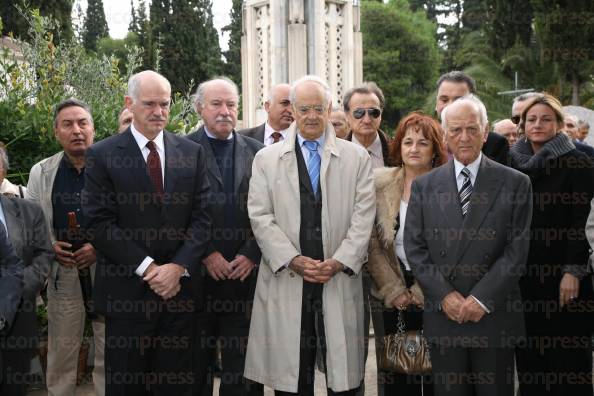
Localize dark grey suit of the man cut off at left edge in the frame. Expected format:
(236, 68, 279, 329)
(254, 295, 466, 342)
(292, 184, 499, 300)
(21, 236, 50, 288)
(0, 180, 54, 396)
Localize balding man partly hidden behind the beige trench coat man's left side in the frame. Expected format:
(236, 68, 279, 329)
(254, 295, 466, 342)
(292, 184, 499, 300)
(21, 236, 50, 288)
(239, 84, 293, 146)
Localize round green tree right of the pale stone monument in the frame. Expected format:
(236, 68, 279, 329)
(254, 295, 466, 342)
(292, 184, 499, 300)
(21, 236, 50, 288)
(361, 0, 440, 132)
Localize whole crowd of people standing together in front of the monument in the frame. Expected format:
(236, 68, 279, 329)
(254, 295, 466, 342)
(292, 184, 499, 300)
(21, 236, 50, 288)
(0, 71, 594, 396)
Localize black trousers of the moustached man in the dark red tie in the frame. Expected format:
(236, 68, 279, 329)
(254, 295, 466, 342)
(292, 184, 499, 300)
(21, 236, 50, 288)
(105, 299, 196, 396)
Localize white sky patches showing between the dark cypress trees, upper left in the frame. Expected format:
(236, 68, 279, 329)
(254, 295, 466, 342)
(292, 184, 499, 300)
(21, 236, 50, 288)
(73, 0, 232, 51)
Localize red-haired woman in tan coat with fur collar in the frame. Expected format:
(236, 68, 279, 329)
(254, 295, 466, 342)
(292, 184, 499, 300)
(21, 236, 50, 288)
(367, 113, 447, 395)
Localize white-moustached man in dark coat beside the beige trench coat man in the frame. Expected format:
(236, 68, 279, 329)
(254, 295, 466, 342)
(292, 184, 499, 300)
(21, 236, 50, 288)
(188, 77, 264, 396)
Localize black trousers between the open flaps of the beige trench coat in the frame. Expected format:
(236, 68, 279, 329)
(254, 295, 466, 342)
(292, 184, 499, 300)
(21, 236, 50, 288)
(274, 281, 359, 396)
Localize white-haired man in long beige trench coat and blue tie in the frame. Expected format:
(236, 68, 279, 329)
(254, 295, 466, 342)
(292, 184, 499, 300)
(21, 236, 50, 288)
(245, 76, 375, 396)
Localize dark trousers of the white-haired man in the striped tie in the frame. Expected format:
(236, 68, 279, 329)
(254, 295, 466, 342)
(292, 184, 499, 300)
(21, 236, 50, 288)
(431, 345, 512, 396)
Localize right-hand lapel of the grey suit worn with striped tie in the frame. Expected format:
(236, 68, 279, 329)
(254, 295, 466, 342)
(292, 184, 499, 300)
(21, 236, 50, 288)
(458, 154, 502, 259)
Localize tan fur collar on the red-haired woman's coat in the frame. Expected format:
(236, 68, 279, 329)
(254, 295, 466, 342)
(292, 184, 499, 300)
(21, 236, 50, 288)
(373, 168, 404, 249)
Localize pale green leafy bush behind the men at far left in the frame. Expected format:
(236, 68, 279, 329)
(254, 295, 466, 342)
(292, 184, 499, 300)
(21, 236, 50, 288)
(0, 7, 197, 184)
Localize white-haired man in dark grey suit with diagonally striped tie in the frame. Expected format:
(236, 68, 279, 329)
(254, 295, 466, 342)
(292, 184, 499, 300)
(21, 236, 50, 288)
(404, 95, 532, 396)
